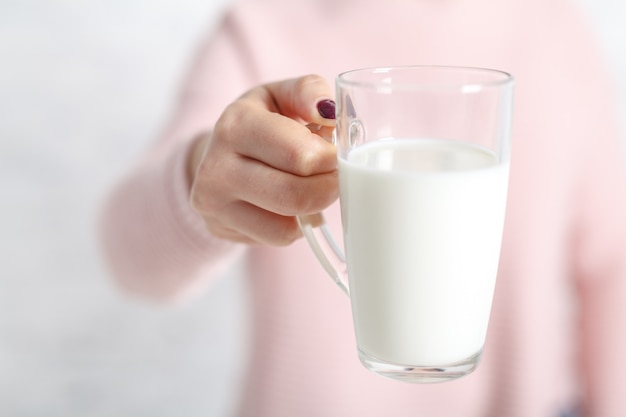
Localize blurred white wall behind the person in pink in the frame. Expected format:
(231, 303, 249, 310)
(0, 0, 626, 417)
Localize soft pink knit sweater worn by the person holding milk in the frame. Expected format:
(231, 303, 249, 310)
(103, 0, 626, 417)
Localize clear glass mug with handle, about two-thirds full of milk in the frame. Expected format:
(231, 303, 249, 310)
(298, 66, 513, 383)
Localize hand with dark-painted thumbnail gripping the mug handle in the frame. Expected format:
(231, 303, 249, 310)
(188, 75, 338, 245)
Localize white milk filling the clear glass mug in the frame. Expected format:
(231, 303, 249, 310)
(339, 139, 508, 366)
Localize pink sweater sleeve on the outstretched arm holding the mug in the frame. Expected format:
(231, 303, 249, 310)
(101, 11, 255, 301)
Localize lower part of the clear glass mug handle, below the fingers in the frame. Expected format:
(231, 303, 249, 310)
(296, 213, 350, 296)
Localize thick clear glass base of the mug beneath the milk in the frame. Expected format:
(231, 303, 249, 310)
(359, 349, 482, 384)
